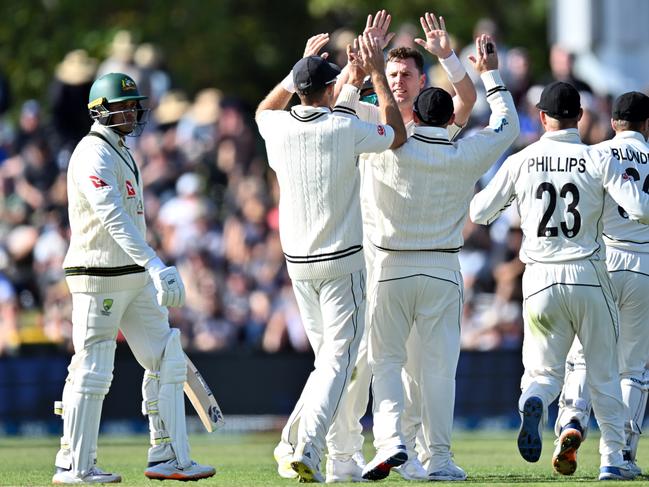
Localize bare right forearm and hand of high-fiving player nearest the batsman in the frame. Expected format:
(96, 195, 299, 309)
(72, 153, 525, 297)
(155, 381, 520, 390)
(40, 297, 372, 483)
(358, 34, 408, 149)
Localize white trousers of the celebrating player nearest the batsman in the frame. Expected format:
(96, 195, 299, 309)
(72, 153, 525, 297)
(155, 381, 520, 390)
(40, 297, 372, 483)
(282, 270, 365, 462)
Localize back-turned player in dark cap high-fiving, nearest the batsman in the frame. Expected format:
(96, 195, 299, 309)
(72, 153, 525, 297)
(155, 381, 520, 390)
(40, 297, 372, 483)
(256, 34, 406, 482)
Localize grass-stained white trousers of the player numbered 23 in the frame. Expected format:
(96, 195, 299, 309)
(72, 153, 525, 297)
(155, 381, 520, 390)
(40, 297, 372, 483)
(519, 261, 624, 466)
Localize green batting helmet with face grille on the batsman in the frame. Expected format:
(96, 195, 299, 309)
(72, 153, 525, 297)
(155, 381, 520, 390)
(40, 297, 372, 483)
(88, 73, 149, 137)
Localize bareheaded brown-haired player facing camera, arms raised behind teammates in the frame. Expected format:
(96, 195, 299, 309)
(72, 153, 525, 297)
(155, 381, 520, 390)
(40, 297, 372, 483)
(327, 10, 476, 482)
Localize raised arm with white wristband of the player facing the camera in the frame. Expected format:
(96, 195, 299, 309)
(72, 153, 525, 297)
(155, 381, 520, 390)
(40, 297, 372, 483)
(415, 12, 477, 126)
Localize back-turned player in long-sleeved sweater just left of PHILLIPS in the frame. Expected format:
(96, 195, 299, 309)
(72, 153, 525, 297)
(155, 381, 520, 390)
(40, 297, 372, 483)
(334, 33, 518, 480)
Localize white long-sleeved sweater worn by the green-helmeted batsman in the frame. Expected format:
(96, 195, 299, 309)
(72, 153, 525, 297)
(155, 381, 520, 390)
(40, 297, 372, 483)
(63, 123, 156, 292)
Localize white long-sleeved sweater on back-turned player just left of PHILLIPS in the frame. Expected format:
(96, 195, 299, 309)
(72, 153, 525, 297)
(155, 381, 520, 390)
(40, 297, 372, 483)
(338, 71, 519, 270)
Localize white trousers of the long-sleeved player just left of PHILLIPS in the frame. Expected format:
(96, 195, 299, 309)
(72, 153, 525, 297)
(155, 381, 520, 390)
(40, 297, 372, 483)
(369, 266, 463, 465)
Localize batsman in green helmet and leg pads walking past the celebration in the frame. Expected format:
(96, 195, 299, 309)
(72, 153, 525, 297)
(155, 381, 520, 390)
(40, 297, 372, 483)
(52, 73, 215, 484)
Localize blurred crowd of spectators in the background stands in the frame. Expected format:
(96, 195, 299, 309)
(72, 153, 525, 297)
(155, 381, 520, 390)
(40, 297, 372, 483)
(0, 19, 636, 355)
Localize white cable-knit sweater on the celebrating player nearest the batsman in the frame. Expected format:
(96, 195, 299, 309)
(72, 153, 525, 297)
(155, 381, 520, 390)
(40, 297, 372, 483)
(257, 105, 394, 279)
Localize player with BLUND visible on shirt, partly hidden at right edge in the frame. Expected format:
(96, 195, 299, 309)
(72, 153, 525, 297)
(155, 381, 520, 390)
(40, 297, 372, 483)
(553, 91, 649, 475)
